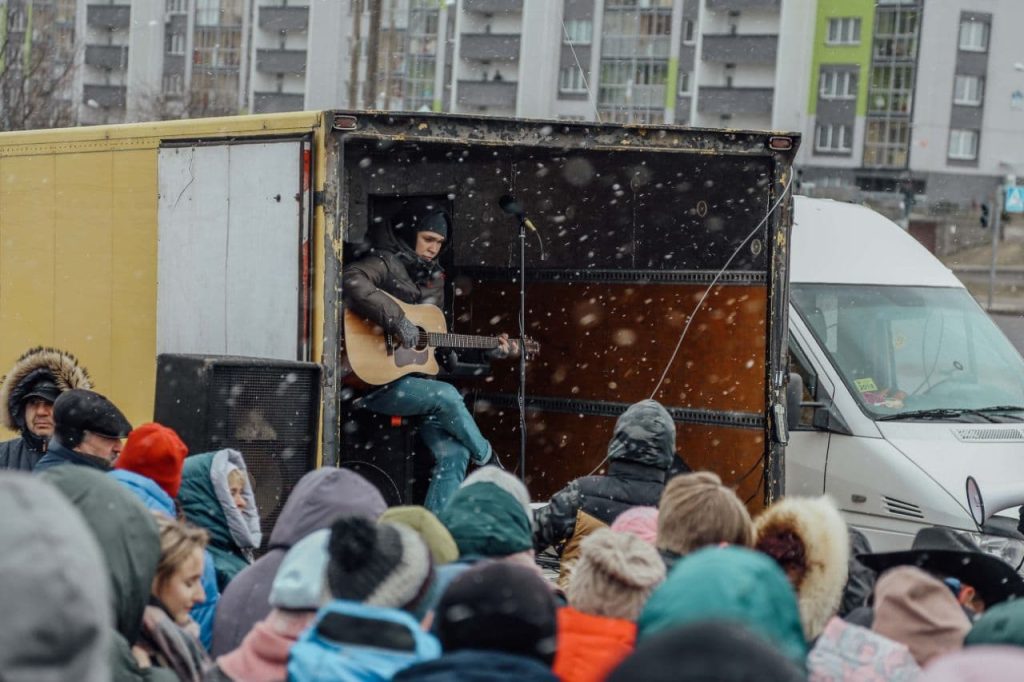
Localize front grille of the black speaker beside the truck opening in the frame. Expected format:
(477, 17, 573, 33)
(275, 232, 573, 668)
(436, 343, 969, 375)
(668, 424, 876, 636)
(208, 365, 318, 543)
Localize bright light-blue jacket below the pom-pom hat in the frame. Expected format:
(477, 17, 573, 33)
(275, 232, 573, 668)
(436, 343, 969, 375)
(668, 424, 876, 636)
(288, 599, 441, 682)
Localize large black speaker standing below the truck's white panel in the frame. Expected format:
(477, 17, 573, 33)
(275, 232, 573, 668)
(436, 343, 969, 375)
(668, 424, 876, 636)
(154, 353, 321, 545)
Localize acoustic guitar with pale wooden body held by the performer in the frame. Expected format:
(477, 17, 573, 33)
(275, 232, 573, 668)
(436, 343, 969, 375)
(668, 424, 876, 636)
(344, 292, 541, 386)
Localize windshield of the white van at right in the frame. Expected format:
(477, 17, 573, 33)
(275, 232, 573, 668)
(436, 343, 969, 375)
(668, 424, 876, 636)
(792, 284, 1024, 421)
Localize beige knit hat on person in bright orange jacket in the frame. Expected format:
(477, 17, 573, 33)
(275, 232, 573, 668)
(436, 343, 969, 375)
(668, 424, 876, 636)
(567, 528, 665, 621)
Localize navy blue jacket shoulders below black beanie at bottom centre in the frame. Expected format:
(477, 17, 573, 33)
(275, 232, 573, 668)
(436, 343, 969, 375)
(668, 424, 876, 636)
(394, 649, 558, 682)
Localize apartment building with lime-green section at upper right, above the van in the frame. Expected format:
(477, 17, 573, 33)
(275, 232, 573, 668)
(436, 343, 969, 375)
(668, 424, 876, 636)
(797, 0, 1024, 219)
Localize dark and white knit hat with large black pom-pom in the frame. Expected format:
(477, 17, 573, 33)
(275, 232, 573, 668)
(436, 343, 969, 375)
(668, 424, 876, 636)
(327, 516, 433, 611)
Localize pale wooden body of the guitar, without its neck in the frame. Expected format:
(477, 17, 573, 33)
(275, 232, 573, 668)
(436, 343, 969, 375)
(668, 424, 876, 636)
(344, 292, 447, 386)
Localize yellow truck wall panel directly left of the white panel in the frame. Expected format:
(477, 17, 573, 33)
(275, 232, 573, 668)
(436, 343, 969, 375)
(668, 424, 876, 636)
(110, 150, 157, 425)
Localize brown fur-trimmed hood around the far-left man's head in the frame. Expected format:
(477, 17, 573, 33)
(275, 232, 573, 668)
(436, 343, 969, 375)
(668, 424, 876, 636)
(0, 346, 92, 431)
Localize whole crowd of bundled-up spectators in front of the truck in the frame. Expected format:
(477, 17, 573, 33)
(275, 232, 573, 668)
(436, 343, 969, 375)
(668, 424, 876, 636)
(0, 349, 1024, 682)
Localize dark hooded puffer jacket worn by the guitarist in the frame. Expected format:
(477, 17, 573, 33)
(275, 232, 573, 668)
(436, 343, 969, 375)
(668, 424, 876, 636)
(342, 206, 451, 334)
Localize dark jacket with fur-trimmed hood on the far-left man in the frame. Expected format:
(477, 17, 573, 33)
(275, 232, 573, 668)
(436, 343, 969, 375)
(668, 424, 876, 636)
(0, 347, 92, 471)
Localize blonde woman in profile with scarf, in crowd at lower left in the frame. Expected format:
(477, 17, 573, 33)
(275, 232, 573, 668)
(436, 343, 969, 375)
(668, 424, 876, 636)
(135, 514, 210, 682)
